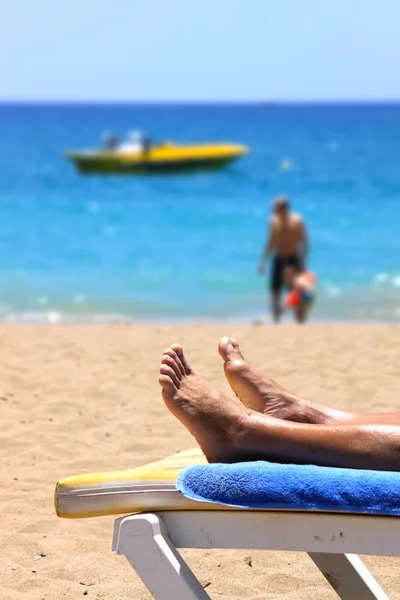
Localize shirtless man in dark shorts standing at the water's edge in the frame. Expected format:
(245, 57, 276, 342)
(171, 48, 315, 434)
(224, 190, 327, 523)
(258, 197, 308, 323)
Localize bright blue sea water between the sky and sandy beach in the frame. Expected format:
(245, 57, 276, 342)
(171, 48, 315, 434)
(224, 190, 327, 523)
(0, 104, 400, 322)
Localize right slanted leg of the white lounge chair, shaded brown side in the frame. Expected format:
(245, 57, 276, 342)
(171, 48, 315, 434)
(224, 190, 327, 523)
(308, 552, 389, 600)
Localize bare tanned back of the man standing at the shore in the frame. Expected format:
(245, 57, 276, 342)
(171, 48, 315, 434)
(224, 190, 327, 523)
(270, 213, 306, 256)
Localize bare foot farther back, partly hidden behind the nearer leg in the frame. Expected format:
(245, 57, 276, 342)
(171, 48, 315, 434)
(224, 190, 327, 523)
(218, 337, 336, 424)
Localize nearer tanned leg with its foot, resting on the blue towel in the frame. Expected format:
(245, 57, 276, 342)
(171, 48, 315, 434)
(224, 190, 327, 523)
(159, 344, 400, 471)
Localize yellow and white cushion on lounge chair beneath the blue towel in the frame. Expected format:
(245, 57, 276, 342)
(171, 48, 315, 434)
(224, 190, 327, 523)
(54, 448, 219, 519)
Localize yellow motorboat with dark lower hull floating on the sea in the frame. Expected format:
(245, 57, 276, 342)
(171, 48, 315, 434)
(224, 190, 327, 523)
(66, 142, 248, 174)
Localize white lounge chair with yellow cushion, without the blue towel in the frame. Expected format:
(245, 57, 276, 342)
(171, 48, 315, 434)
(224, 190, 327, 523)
(56, 449, 400, 600)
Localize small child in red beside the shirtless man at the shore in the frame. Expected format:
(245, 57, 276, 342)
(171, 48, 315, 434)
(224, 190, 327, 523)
(283, 266, 315, 323)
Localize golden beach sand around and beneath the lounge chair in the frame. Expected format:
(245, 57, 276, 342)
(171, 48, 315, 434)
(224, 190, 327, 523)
(0, 325, 400, 600)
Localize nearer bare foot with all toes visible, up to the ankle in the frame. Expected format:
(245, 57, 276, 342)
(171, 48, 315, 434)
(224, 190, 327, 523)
(158, 344, 250, 463)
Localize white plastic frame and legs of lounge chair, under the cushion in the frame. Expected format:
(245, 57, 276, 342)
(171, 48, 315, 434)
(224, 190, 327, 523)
(113, 510, 400, 600)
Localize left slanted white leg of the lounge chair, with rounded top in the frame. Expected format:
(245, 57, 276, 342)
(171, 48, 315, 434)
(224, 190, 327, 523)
(115, 514, 210, 600)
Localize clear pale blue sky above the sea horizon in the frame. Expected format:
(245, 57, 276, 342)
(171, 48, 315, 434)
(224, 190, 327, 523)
(0, 0, 400, 101)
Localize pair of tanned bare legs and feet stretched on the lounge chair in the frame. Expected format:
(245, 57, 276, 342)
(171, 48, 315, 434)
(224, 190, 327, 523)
(158, 337, 400, 471)
